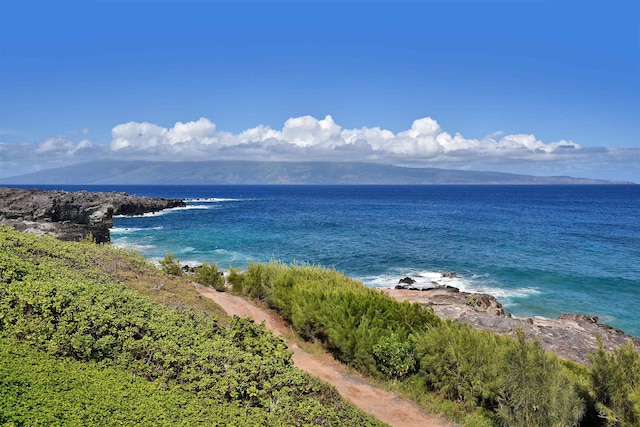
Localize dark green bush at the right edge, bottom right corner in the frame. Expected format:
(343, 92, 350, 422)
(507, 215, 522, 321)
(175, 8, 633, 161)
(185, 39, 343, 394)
(590, 341, 640, 427)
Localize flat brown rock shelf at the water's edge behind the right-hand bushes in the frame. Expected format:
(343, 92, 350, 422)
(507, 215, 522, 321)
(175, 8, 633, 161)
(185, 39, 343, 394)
(381, 273, 640, 364)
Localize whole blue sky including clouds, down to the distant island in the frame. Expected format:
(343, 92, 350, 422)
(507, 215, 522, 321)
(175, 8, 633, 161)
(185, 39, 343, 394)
(0, 0, 640, 182)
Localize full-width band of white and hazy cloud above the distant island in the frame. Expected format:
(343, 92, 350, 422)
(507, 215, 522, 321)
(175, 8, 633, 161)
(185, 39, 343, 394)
(0, 115, 640, 180)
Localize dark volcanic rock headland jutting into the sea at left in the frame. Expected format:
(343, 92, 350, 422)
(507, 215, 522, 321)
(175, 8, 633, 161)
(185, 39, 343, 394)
(0, 187, 185, 243)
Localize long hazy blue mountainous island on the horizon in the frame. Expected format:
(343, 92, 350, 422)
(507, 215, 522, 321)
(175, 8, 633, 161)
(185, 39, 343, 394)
(0, 160, 631, 185)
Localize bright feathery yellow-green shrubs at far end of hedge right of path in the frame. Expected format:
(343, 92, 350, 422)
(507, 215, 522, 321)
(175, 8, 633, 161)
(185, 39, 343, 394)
(229, 261, 440, 375)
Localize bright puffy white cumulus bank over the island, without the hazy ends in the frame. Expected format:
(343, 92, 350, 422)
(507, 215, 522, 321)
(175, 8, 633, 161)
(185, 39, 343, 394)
(110, 115, 582, 165)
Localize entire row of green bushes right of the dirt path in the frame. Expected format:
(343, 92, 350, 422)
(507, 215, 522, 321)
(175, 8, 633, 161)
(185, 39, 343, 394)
(229, 261, 640, 426)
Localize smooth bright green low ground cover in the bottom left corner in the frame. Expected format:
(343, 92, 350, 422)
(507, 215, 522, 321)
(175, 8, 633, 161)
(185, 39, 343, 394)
(0, 338, 272, 426)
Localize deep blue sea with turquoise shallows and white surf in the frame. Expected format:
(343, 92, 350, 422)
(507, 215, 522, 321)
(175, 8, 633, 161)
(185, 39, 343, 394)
(22, 185, 640, 336)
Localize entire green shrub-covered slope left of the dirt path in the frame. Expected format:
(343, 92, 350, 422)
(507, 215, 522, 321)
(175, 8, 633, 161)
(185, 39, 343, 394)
(0, 226, 379, 425)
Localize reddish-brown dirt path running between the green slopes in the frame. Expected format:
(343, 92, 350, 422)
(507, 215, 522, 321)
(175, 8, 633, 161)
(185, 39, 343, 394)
(195, 284, 454, 427)
